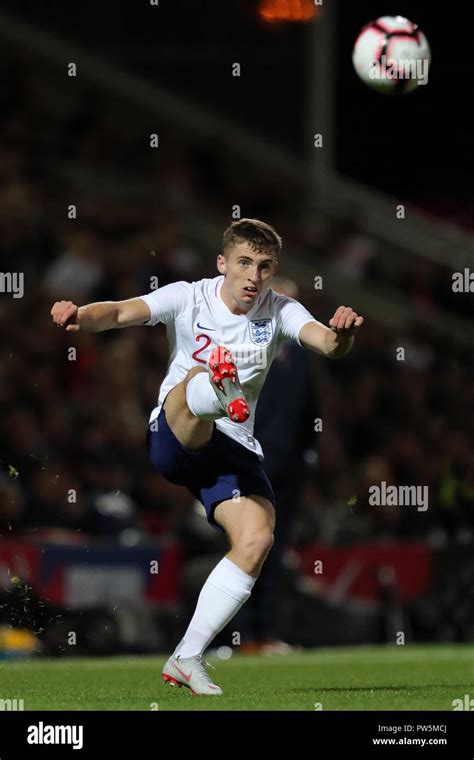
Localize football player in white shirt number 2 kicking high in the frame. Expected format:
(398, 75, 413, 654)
(51, 219, 363, 695)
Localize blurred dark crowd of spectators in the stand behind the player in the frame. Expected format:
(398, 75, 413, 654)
(0, 46, 474, 543)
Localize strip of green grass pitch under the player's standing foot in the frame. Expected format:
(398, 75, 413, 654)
(0, 645, 474, 711)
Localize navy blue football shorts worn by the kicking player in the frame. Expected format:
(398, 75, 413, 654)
(146, 407, 275, 530)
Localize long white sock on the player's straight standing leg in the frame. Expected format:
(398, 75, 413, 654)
(175, 560, 257, 657)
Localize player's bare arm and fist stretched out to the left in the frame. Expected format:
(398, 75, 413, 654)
(51, 298, 151, 332)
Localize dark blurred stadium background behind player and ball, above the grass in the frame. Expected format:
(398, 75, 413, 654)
(0, 0, 474, 656)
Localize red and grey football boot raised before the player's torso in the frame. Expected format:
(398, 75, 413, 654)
(208, 346, 250, 422)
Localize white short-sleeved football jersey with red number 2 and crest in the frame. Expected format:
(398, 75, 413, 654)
(140, 275, 317, 460)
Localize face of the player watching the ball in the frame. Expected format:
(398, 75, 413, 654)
(217, 242, 277, 312)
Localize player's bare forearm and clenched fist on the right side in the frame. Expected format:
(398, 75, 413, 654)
(299, 306, 364, 359)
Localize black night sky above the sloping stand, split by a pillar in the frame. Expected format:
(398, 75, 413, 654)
(2, 0, 474, 202)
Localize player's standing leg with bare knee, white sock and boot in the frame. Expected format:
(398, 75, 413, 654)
(163, 495, 275, 695)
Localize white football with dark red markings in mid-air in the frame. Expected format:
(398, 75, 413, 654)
(352, 16, 431, 94)
